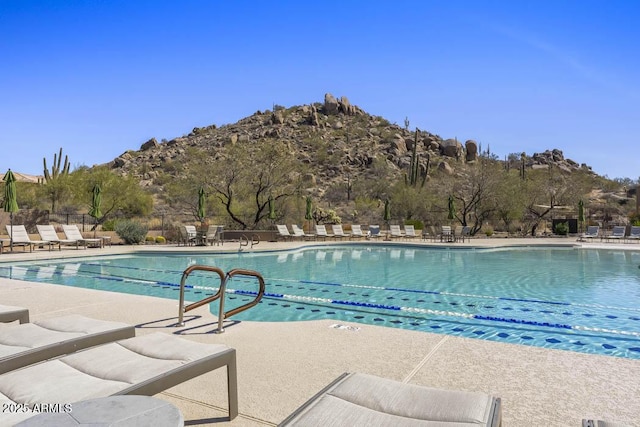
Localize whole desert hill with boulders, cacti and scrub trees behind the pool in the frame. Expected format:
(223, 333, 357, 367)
(3, 94, 638, 239)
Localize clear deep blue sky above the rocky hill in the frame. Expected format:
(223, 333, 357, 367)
(0, 0, 640, 180)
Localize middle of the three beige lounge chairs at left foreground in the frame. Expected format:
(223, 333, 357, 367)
(0, 314, 136, 374)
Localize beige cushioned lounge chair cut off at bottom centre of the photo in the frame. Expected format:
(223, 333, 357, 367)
(279, 373, 502, 427)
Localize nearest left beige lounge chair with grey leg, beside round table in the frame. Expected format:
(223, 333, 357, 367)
(0, 333, 238, 425)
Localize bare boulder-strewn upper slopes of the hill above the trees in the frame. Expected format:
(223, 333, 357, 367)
(110, 93, 590, 196)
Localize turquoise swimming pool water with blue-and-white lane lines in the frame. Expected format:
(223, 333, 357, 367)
(0, 245, 640, 359)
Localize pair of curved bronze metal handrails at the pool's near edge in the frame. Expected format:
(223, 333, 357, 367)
(178, 265, 265, 334)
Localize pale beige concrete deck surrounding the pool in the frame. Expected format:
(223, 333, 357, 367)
(0, 238, 640, 427)
